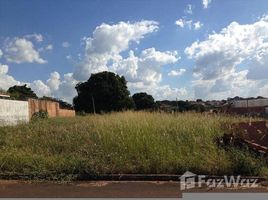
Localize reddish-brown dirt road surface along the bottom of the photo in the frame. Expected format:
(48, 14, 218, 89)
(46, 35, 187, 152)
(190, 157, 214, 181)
(0, 180, 268, 198)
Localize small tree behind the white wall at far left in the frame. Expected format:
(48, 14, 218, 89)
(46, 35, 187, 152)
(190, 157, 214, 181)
(7, 84, 38, 100)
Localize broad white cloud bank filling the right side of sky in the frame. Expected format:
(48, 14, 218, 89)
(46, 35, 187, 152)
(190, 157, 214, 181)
(185, 18, 268, 97)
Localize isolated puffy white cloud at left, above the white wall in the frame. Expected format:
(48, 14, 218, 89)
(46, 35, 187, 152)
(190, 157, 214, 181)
(5, 37, 47, 64)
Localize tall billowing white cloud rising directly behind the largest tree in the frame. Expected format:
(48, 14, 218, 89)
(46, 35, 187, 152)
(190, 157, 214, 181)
(73, 21, 186, 99)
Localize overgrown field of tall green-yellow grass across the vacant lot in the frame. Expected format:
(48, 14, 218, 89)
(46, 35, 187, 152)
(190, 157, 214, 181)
(0, 112, 268, 180)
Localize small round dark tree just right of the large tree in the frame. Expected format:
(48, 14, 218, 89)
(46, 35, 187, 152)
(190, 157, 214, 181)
(132, 92, 155, 110)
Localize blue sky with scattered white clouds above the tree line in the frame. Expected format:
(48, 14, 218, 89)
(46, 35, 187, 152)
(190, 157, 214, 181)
(0, 0, 268, 102)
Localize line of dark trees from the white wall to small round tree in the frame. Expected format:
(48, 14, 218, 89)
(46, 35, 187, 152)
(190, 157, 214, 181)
(1, 71, 156, 113)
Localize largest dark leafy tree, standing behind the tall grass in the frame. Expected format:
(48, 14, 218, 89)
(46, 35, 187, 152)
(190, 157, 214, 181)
(73, 71, 134, 113)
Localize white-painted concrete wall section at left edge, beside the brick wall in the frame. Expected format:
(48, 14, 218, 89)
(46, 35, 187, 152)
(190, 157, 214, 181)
(0, 99, 29, 126)
